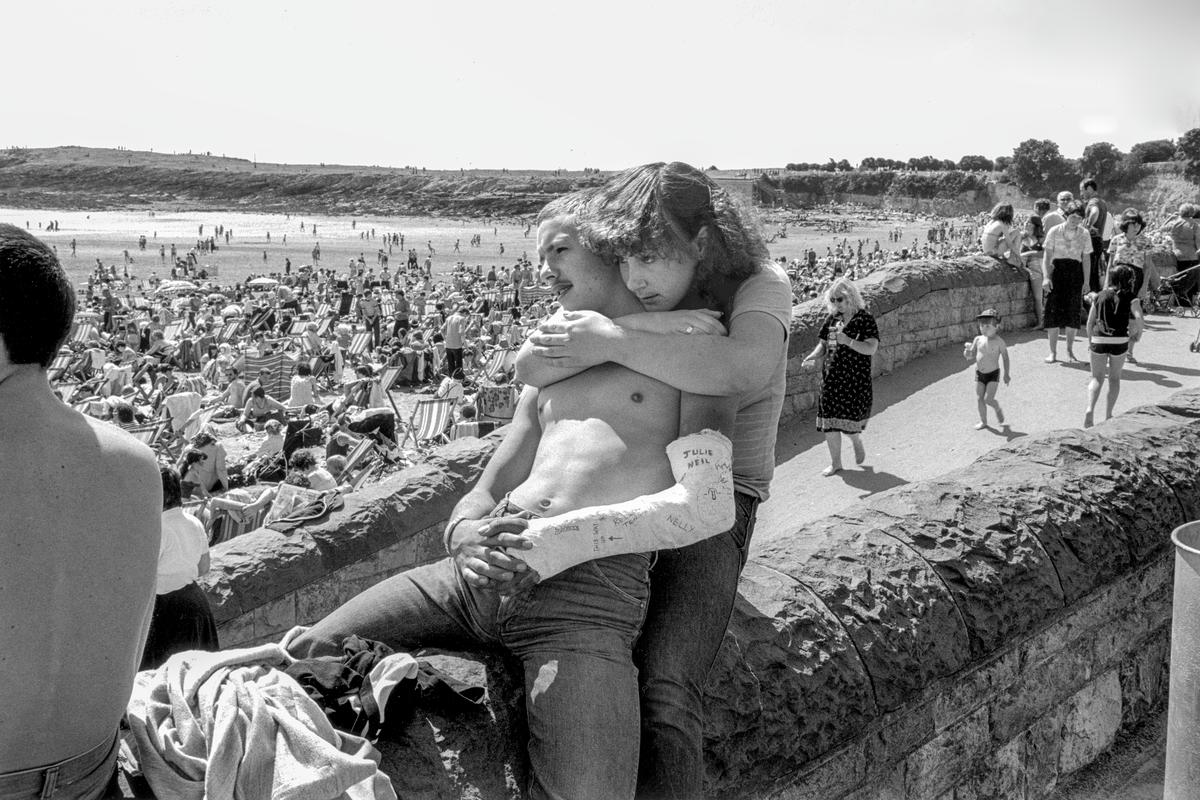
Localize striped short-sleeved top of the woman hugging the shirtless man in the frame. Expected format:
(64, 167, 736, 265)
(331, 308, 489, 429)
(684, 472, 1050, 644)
(730, 261, 792, 500)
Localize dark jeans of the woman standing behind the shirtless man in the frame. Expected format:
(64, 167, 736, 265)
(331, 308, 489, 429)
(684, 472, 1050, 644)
(634, 492, 758, 800)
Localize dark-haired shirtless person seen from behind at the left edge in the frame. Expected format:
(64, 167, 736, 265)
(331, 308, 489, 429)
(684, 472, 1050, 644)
(0, 225, 162, 800)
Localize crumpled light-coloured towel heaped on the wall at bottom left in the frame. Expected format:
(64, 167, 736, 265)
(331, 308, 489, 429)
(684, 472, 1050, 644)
(125, 644, 396, 800)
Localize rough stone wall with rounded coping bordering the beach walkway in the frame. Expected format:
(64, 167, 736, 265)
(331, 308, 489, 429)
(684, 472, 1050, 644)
(206, 258, 1185, 800)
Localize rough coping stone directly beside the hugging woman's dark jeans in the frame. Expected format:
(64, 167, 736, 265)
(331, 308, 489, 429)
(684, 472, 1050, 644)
(704, 561, 876, 794)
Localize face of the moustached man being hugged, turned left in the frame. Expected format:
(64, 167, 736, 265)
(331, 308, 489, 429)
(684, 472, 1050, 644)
(538, 217, 625, 311)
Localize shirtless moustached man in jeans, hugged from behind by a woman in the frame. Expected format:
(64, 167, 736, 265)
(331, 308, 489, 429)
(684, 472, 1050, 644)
(289, 199, 733, 800)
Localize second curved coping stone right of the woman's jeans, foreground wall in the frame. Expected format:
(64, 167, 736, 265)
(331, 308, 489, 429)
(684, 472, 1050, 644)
(754, 515, 968, 709)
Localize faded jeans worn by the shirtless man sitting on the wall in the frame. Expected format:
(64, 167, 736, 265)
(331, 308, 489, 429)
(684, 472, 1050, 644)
(289, 504, 650, 800)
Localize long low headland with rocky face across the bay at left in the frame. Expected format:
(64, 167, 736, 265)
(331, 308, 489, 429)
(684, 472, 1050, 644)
(0, 148, 601, 217)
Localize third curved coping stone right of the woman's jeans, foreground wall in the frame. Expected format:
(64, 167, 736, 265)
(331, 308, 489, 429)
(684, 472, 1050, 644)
(849, 480, 1064, 657)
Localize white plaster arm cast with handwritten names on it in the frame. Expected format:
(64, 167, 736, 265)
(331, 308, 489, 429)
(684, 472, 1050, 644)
(512, 429, 734, 581)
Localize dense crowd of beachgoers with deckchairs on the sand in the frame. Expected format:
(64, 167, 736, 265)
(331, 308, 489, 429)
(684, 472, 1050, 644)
(49, 191, 1190, 539)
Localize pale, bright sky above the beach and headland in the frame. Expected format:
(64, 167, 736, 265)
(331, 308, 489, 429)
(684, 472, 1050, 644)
(0, 0, 1200, 169)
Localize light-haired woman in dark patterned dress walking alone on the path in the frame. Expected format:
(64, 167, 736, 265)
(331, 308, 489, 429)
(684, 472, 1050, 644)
(804, 278, 880, 476)
